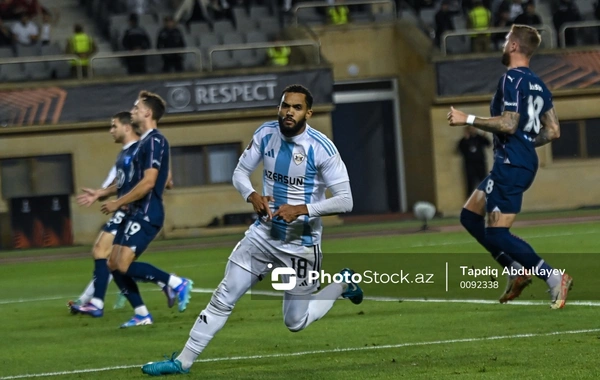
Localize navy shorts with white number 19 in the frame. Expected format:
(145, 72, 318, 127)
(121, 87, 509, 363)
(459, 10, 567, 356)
(113, 215, 161, 257)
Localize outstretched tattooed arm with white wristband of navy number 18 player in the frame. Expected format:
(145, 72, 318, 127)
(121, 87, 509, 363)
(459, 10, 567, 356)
(448, 107, 520, 135)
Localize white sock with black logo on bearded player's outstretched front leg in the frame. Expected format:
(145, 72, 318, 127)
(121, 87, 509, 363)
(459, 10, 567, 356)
(177, 305, 229, 369)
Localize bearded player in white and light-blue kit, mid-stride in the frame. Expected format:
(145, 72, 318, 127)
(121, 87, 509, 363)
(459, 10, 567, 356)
(142, 85, 363, 376)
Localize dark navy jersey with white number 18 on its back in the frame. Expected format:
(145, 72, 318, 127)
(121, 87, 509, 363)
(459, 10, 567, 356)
(490, 67, 553, 172)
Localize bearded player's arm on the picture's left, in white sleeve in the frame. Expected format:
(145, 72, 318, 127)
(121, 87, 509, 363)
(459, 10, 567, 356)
(231, 135, 273, 220)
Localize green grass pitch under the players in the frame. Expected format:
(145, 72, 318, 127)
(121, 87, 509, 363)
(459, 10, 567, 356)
(0, 218, 600, 380)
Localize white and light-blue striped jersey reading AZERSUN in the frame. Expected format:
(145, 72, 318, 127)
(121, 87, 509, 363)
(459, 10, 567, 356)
(240, 121, 350, 247)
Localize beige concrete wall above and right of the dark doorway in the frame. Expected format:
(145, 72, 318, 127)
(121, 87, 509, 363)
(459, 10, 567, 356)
(315, 20, 435, 209)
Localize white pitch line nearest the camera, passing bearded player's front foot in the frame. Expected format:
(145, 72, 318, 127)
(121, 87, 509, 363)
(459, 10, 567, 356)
(0, 329, 600, 380)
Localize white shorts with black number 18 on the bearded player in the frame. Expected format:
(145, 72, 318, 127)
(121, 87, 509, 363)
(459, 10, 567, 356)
(229, 229, 323, 295)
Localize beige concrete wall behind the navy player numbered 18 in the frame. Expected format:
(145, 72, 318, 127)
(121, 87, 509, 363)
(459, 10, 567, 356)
(431, 95, 600, 215)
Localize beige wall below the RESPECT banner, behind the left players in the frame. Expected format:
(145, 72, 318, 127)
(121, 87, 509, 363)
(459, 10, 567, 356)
(0, 110, 331, 243)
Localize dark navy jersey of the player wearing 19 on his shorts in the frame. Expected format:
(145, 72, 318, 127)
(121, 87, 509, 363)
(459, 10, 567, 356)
(130, 129, 170, 226)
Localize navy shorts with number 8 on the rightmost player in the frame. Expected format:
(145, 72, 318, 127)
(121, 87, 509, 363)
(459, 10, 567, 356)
(477, 163, 535, 214)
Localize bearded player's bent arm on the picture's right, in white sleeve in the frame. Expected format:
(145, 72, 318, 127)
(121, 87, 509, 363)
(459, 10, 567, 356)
(273, 154, 353, 223)
